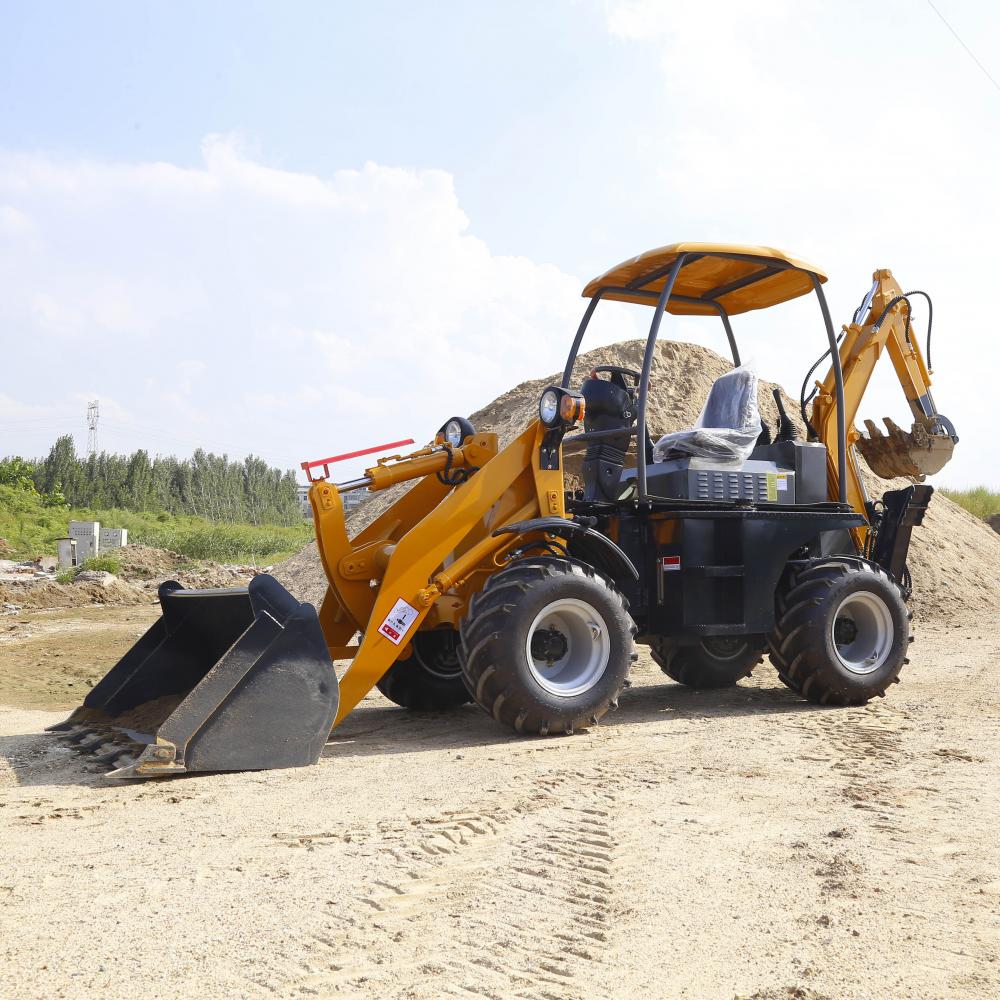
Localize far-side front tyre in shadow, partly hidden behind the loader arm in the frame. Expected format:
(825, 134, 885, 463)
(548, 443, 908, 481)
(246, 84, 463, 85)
(375, 628, 472, 712)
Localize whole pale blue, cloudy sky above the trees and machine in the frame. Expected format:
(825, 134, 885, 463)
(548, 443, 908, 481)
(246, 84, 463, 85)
(0, 0, 1000, 486)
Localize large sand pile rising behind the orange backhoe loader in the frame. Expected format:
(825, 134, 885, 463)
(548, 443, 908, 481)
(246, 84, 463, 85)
(274, 340, 1000, 619)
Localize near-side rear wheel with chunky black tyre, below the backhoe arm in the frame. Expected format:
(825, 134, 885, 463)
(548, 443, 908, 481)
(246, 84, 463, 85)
(770, 560, 910, 705)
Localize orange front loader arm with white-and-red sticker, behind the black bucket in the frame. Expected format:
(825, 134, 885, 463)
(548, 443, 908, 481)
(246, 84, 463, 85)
(309, 421, 565, 725)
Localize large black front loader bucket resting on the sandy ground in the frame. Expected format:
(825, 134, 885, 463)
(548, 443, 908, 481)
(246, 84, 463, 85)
(52, 575, 339, 777)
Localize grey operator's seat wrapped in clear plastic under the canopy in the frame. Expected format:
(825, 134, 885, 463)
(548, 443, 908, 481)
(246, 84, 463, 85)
(653, 366, 762, 466)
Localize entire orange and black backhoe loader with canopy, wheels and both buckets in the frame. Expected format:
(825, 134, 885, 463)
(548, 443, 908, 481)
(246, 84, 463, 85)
(50, 243, 958, 777)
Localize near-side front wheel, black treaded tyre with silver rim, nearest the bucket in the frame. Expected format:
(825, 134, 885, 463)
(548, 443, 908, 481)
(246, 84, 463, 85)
(460, 557, 636, 736)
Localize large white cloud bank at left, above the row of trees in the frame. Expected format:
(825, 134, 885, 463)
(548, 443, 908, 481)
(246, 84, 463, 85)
(0, 136, 583, 476)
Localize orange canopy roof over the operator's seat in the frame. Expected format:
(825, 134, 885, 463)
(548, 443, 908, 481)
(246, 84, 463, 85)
(583, 243, 826, 316)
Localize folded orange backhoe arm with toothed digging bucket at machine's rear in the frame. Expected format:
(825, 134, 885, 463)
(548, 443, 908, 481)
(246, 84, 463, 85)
(810, 269, 958, 550)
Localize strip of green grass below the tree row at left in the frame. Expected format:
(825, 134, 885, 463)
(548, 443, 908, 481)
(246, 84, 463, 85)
(0, 485, 313, 572)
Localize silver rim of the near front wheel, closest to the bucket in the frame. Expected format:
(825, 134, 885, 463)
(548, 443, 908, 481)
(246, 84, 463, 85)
(524, 598, 611, 698)
